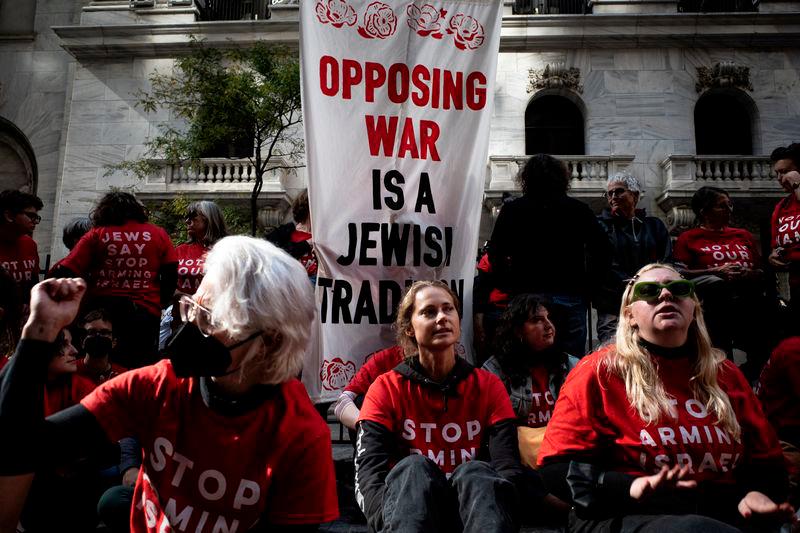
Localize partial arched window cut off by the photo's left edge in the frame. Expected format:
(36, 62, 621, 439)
(0, 117, 37, 194)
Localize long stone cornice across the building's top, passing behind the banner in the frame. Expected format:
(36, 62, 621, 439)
(53, 13, 800, 59)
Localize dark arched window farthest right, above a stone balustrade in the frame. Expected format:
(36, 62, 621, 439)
(694, 89, 755, 155)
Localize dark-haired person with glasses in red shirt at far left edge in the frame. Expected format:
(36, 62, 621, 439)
(0, 189, 44, 298)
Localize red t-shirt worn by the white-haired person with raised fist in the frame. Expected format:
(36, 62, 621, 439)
(81, 360, 339, 533)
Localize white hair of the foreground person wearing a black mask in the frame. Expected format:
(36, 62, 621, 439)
(204, 235, 314, 384)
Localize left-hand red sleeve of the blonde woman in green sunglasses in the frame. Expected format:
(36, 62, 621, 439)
(538, 354, 616, 466)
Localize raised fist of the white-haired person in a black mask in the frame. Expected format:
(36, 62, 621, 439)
(22, 278, 86, 342)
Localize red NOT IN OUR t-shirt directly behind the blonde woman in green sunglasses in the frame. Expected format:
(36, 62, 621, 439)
(675, 227, 760, 270)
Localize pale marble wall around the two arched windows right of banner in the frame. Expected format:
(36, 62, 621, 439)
(489, 48, 800, 216)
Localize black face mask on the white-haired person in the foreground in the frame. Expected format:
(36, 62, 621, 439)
(164, 322, 261, 377)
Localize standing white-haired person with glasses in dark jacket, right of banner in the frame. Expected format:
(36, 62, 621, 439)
(593, 171, 672, 342)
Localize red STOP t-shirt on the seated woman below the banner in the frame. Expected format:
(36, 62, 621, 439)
(359, 368, 515, 476)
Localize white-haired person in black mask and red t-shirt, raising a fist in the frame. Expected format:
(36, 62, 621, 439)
(0, 237, 338, 533)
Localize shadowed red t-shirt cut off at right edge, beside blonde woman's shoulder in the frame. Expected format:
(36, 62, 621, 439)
(757, 337, 800, 445)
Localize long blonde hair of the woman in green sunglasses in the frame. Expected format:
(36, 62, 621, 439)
(604, 263, 741, 441)
